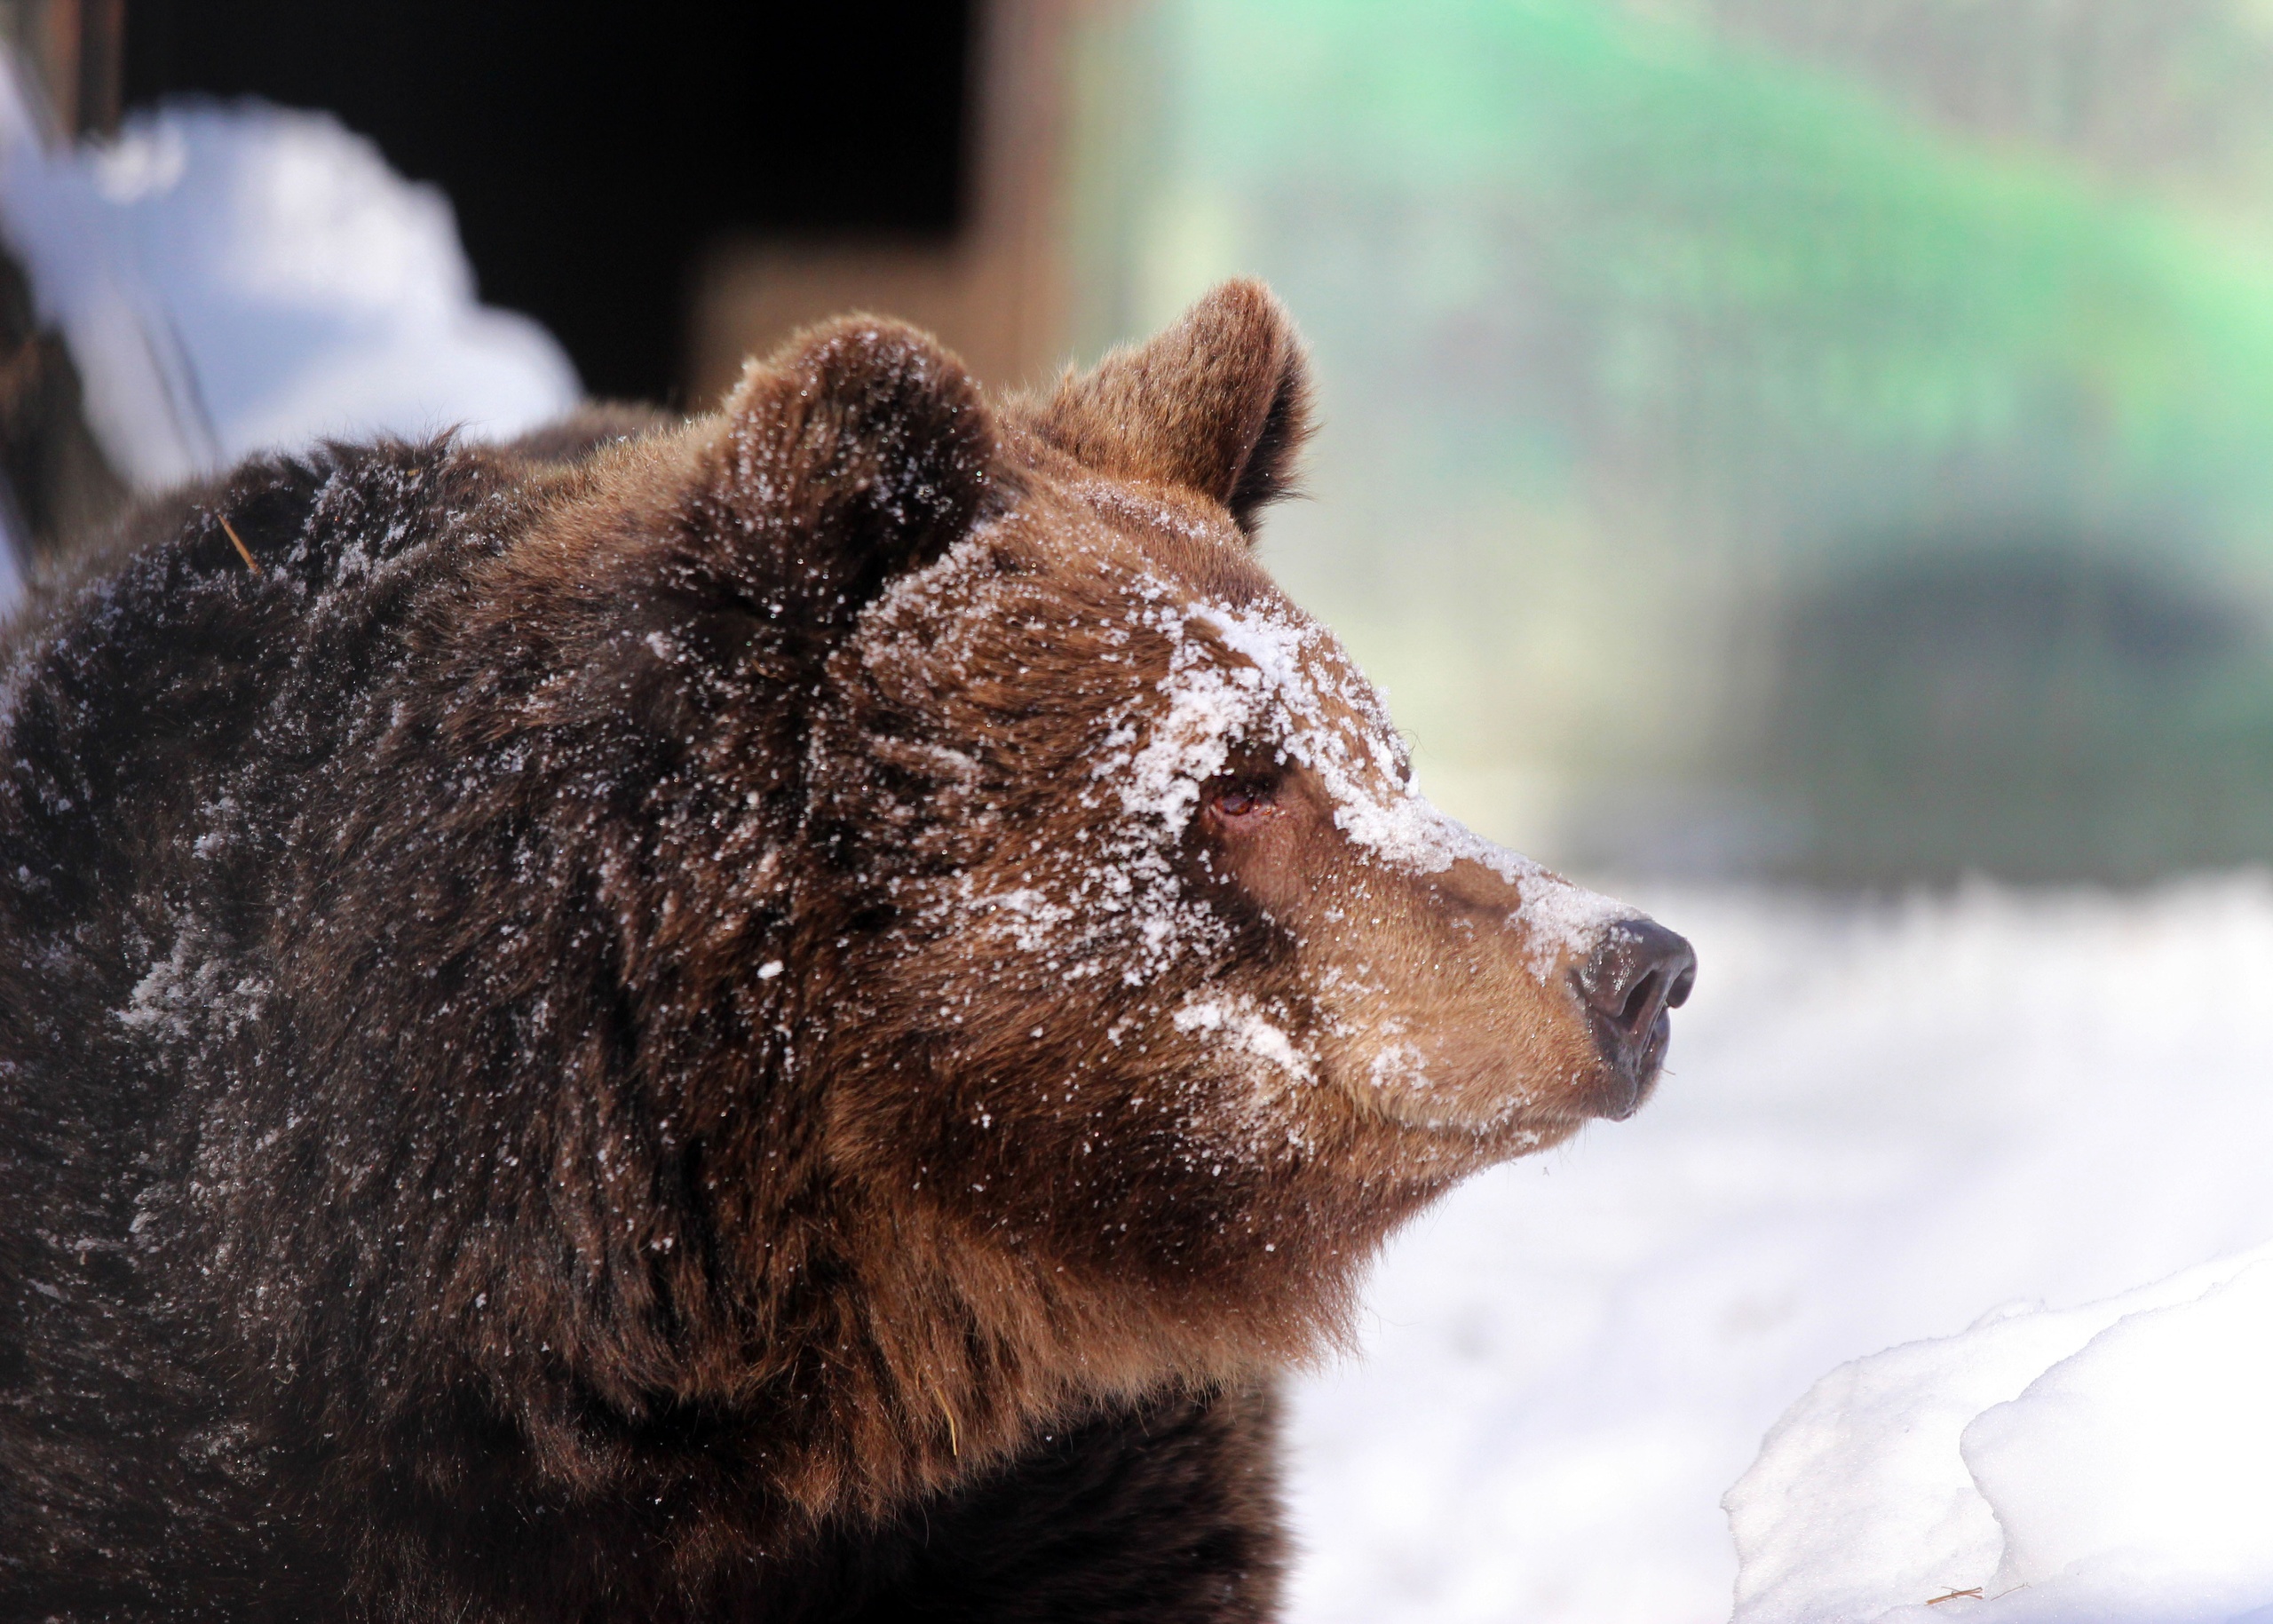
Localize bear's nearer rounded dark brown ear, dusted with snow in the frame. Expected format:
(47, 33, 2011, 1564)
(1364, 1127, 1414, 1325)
(721, 316, 995, 621)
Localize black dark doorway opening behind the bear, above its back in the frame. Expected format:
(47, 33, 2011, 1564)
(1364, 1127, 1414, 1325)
(125, 0, 975, 400)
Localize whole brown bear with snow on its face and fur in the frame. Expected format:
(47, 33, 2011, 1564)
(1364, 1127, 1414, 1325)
(0, 284, 1691, 1624)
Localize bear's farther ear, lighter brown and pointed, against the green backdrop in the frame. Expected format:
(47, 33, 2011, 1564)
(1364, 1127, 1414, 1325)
(1036, 282, 1310, 535)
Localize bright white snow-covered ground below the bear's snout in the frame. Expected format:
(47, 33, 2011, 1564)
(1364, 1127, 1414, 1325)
(1291, 875, 2273, 1624)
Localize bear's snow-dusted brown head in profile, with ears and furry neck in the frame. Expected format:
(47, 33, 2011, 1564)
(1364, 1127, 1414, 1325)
(418, 282, 1691, 1501)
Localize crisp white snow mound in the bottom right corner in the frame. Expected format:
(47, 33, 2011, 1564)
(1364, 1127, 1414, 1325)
(1725, 1247, 2273, 1624)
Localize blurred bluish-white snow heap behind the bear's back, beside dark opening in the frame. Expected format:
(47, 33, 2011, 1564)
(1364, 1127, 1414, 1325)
(0, 53, 580, 489)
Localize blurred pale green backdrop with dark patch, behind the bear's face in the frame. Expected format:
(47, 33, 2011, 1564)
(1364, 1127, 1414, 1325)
(1071, 0, 2273, 883)
